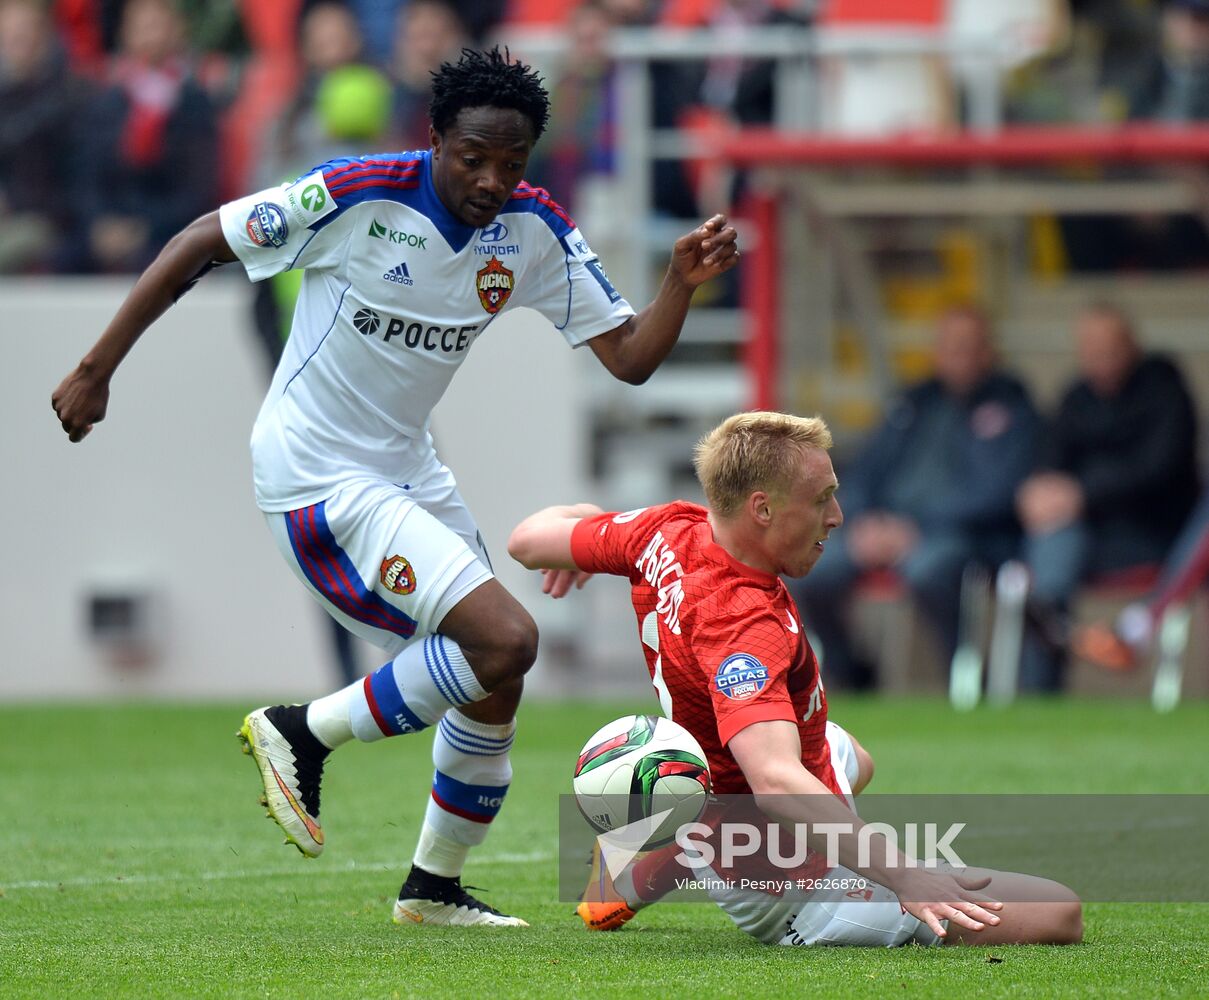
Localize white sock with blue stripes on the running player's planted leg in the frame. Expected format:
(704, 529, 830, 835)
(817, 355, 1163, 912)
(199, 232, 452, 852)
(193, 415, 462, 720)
(413, 709, 516, 877)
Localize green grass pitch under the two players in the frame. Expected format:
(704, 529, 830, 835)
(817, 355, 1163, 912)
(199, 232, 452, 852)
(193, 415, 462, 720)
(0, 696, 1209, 1000)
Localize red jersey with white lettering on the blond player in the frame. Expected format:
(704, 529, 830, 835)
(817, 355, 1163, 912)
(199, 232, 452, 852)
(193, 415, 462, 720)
(571, 502, 841, 794)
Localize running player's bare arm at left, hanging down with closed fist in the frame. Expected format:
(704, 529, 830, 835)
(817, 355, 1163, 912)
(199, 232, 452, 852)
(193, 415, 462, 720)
(51, 212, 236, 441)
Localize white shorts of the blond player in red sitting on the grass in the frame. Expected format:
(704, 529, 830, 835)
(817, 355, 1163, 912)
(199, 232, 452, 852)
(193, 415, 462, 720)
(696, 722, 941, 948)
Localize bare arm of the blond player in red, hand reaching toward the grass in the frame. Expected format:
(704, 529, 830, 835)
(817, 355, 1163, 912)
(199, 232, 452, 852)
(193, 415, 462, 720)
(728, 721, 1003, 938)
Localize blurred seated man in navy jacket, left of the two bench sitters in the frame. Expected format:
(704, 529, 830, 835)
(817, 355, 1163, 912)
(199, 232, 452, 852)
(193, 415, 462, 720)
(791, 307, 1037, 687)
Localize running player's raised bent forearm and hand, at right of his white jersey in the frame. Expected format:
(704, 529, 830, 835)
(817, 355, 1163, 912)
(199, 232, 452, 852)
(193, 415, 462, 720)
(588, 215, 739, 386)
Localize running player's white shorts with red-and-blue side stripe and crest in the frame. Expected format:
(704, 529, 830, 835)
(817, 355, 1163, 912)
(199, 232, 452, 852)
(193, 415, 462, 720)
(265, 462, 492, 657)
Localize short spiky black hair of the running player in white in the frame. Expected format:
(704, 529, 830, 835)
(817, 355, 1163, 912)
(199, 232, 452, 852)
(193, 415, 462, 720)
(428, 45, 550, 139)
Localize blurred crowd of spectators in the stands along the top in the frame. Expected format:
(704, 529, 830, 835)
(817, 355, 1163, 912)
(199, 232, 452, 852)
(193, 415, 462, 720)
(7, 0, 1209, 273)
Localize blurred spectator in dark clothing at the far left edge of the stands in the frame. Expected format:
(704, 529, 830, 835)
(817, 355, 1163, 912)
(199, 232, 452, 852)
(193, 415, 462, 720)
(0, 0, 83, 272)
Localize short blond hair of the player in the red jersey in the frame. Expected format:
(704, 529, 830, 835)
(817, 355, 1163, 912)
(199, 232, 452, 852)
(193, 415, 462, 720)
(693, 410, 832, 518)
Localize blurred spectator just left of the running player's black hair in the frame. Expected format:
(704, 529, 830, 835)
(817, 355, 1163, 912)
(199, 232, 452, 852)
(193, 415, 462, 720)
(391, 0, 470, 149)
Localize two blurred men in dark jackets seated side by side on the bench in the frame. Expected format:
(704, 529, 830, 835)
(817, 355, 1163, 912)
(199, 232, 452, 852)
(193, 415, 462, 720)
(791, 301, 1209, 692)
